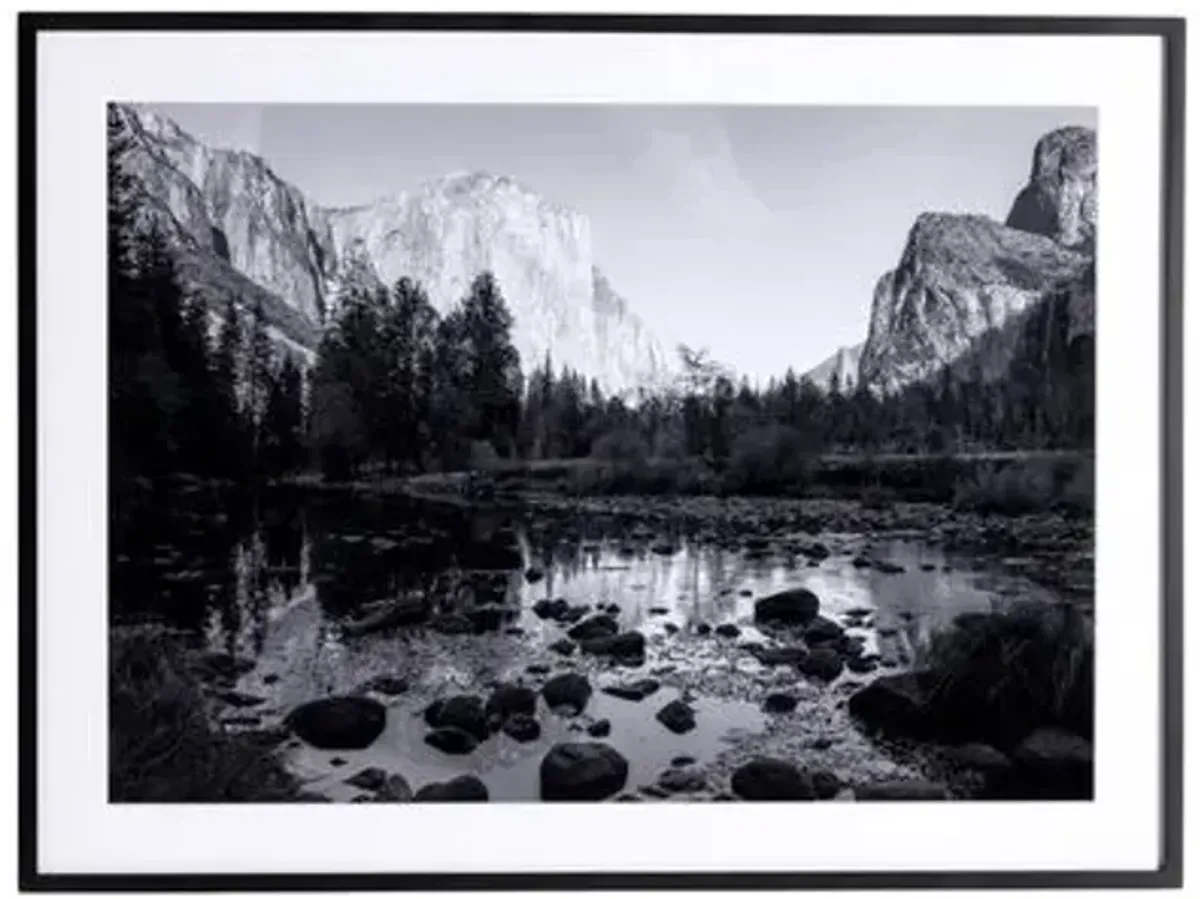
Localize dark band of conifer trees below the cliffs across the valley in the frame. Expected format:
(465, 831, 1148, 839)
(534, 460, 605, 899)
(108, 100, 1093, 492)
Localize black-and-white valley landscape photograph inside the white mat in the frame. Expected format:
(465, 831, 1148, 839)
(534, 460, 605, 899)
(107, 103, 1103, 803)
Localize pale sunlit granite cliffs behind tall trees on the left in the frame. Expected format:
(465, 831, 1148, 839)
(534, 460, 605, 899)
(110, 106, 671, 391)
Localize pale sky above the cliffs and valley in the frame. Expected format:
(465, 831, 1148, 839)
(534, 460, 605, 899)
(145, 104, 1096, 380)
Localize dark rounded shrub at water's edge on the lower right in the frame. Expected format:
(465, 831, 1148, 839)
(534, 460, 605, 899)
(923, 601, 1094, 749)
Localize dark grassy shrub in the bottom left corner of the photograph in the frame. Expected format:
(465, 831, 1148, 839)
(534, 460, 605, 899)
(108, 628, 302, 802)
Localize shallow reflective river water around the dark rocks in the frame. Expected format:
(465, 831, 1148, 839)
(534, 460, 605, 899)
(112, 492, 1065, 801)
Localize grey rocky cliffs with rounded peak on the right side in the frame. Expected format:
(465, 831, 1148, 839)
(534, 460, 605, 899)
(859, 127, 1097, 390)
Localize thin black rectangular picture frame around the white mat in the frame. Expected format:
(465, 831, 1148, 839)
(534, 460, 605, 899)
(18, 13, 1186, 892)
